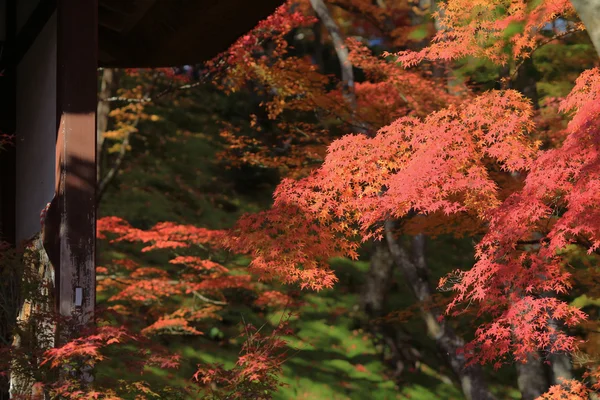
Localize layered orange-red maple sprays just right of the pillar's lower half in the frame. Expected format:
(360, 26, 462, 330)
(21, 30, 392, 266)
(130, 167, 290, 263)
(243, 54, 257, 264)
(96, 217, 300, 335)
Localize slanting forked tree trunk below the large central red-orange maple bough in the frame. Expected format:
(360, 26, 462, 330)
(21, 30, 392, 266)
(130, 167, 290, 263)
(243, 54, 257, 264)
(385, 221, 495, 400)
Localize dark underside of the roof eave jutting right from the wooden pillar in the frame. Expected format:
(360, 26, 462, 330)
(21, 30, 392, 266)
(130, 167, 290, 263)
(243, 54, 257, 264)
(98, 0, 283, 67)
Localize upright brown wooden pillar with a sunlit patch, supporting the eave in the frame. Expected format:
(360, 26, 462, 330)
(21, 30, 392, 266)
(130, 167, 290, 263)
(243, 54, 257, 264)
(49, 0, 98, 332)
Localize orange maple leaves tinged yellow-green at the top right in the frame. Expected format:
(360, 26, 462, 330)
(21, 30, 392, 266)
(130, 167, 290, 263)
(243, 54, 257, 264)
(398, 0, 583, 67)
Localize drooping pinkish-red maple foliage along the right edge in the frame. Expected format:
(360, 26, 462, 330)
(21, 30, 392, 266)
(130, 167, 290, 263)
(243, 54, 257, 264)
(452, 69, 600, 366)
